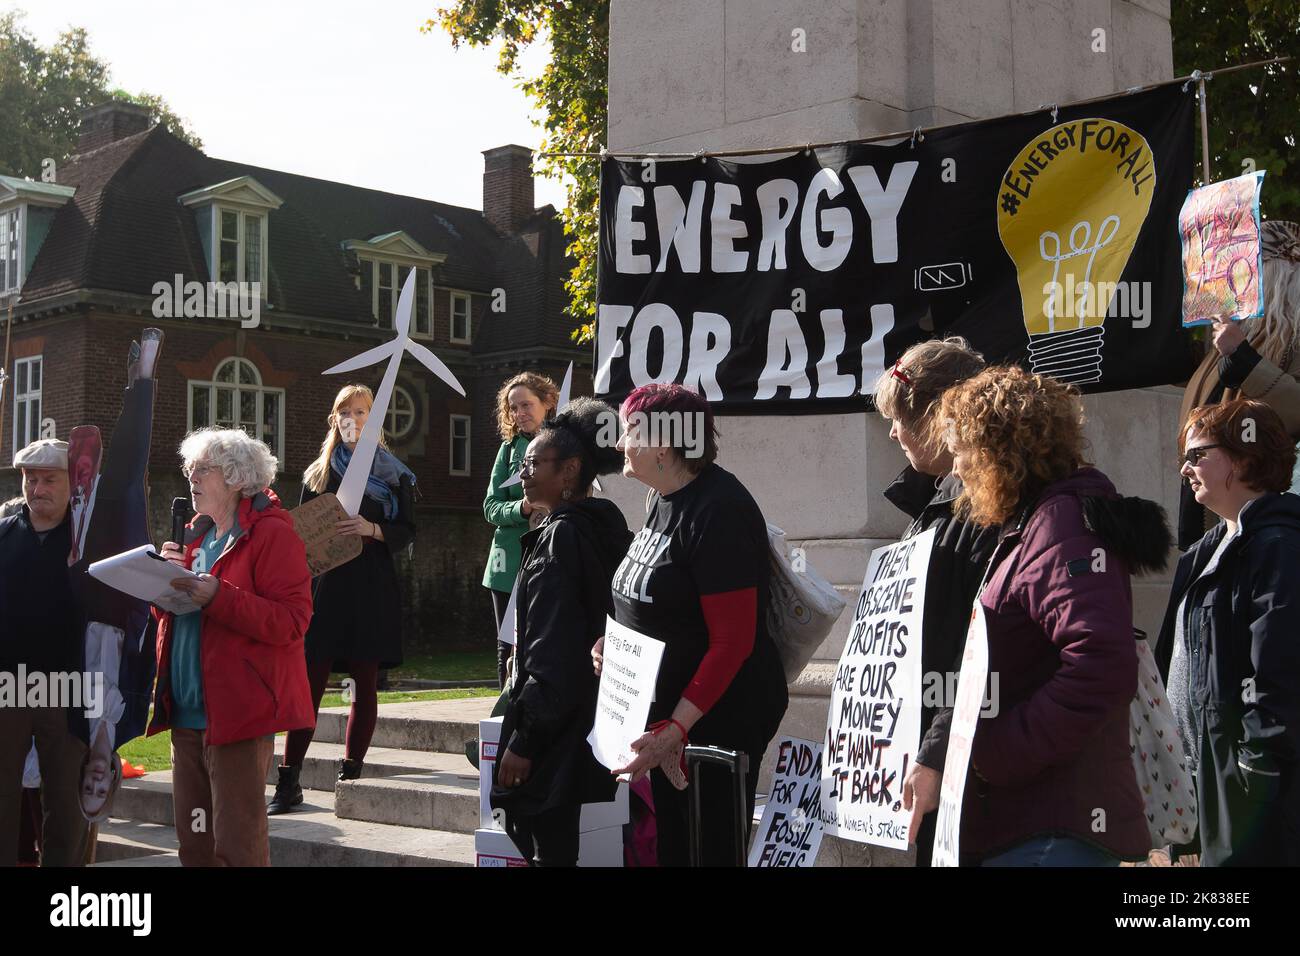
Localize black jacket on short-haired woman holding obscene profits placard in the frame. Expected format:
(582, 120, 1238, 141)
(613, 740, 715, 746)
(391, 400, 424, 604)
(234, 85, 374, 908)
(885, 466, 1000, 773)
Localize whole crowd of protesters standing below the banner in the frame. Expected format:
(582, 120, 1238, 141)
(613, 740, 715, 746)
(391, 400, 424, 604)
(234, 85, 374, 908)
(0, 222, 1300, 866)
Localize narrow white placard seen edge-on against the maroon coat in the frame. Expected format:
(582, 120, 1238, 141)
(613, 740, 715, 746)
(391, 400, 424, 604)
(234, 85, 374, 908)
(930, 600, 988, 866)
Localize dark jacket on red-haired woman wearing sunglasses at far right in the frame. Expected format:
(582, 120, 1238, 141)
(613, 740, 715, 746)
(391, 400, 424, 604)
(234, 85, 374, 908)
(1156, 494, 1300, 866)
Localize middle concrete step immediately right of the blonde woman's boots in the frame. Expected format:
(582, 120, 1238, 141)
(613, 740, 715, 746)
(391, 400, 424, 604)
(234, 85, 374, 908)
(334, 775, 478, 834)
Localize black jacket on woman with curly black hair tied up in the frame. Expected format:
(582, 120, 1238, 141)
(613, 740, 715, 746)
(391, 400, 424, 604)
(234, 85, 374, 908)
(491, 498, 632, 816)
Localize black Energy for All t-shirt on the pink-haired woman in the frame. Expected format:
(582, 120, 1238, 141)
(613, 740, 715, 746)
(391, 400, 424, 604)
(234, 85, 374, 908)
(612, 464, 787, 743)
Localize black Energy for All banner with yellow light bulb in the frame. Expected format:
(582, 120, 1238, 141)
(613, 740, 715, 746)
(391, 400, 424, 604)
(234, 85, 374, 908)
(595, 85, 1195, 414)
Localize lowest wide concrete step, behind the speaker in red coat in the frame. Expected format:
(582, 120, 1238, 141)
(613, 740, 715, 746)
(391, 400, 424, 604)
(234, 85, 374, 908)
(101, 773, 477, 866)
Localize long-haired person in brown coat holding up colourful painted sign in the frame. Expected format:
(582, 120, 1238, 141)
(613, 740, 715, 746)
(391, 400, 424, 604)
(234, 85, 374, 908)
(1178, 220, 1300, 550)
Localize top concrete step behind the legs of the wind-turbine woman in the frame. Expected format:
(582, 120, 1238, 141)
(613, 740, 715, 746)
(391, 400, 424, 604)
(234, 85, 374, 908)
(315, 697, 497, 754)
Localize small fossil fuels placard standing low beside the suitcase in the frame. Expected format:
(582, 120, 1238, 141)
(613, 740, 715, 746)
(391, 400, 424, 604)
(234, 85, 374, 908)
(749, 737, 826, 868)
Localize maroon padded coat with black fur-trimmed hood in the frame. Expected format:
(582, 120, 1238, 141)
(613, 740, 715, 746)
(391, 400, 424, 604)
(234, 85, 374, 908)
(961, 468, 1170, 861)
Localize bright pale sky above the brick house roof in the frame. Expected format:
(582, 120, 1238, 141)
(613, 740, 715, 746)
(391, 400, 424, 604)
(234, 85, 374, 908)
(8, 0, 564, 209)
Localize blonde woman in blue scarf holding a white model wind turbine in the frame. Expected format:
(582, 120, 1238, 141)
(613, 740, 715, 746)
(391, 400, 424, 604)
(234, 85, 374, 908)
(267, 385, 416, 816)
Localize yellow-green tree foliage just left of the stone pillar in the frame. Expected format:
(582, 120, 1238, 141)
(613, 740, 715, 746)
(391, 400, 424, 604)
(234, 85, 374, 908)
(421, 0, 610, 342)
